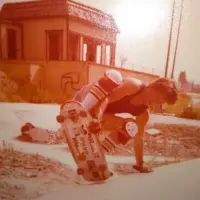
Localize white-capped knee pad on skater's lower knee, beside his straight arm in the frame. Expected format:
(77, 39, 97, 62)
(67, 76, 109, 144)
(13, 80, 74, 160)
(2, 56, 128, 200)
(118, 119, 138, 145)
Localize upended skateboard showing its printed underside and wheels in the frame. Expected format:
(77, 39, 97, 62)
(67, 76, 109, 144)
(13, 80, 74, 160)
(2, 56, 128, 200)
(56, 101, 113, 182)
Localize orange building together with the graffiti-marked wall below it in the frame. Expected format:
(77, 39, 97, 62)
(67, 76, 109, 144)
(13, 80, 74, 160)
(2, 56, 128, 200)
(0, 0, 158, 100)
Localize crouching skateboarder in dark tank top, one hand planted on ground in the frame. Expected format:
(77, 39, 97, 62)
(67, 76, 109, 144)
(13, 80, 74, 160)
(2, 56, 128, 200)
(22, 70, 178, 173)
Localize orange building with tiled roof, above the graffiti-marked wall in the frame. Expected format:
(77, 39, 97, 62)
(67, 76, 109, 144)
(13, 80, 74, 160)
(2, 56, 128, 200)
(0, 0, 119, 65)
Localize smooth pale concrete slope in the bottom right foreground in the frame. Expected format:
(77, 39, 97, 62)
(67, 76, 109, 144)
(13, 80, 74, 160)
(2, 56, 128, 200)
(38, 159, 200, 200)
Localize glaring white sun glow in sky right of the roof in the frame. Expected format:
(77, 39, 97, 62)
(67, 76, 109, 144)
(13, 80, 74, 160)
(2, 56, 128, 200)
(115, 0, 166, 37)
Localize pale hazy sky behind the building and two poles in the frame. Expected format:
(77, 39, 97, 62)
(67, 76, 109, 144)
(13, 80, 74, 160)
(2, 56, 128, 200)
(0, 0, 200, 83)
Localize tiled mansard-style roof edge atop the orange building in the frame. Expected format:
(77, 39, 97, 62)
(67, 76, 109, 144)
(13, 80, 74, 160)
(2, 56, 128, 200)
(0, 0, 119, 33)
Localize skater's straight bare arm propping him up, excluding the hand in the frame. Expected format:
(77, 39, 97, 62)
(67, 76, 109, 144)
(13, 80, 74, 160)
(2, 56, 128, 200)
(133, 111, 149, 166)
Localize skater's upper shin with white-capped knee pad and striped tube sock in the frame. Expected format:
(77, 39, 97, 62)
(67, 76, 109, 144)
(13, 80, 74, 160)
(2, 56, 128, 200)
(82, 70, 122, 111)
